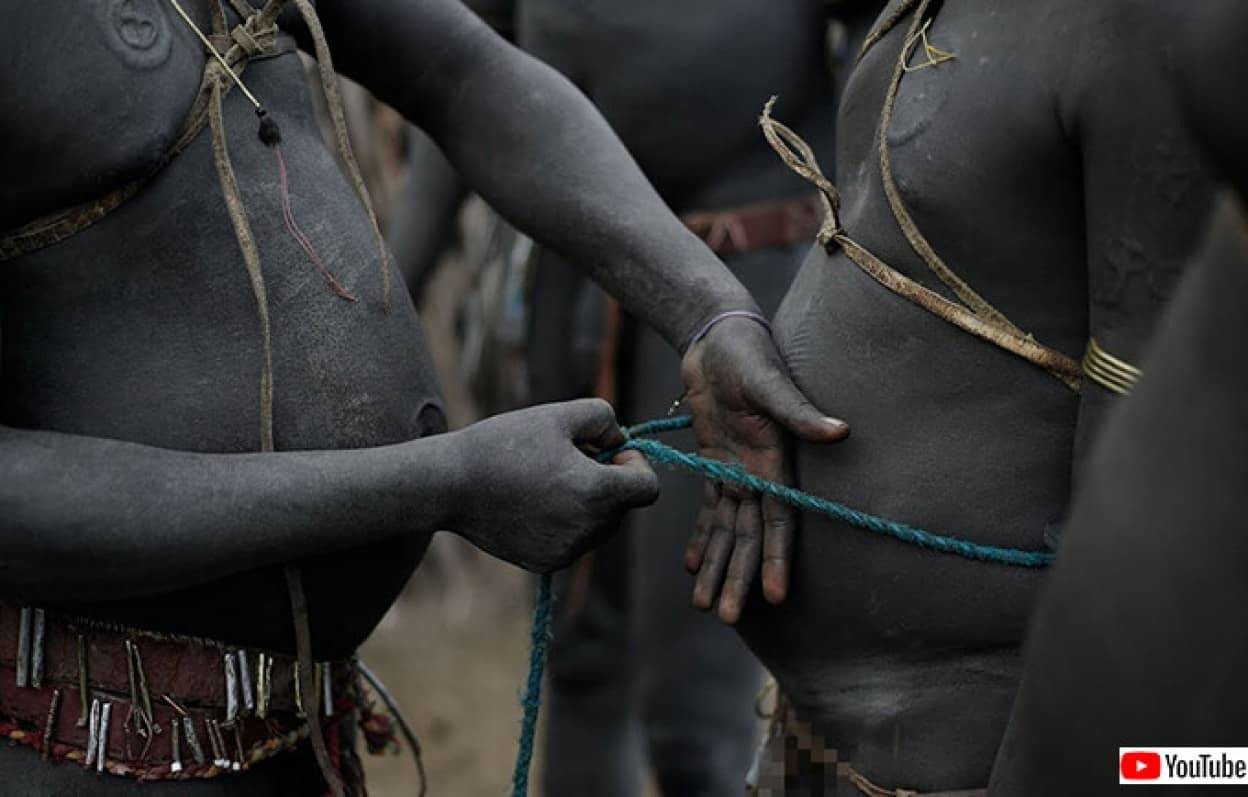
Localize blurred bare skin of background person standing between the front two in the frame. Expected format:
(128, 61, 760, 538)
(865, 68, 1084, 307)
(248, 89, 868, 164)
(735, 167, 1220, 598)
(511, 0, 874, 797)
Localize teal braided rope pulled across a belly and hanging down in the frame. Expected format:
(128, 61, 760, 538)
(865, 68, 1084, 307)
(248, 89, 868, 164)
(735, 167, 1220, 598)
(512, 415, 1053, 797)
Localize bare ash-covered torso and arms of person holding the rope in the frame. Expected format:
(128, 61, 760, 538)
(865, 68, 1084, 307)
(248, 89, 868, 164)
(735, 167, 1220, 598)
(0, 0, 844, 795)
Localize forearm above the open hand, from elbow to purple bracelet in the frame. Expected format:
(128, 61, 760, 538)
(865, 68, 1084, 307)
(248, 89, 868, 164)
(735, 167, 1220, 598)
(433, 57, 756, 352)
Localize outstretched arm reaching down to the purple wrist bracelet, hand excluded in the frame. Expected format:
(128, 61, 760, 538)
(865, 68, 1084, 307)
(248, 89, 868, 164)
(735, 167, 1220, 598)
(312, 0, 756, 349)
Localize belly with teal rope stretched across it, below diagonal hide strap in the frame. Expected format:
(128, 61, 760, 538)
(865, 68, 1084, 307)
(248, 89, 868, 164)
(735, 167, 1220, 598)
(744, 248, 1077, 671)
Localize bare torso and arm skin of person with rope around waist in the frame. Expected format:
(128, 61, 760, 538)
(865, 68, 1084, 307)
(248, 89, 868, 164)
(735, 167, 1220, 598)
(723, 0, 1211, 793)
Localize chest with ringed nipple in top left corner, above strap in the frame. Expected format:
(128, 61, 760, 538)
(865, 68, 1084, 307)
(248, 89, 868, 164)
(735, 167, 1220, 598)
(0, 0, 214, 229)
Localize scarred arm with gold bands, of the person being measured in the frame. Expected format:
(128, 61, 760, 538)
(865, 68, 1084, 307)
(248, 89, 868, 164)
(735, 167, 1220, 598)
(1061, 0, 1213, 478)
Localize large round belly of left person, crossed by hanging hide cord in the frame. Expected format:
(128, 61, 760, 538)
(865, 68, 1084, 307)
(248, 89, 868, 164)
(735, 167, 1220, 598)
(0, 59, 442, 657)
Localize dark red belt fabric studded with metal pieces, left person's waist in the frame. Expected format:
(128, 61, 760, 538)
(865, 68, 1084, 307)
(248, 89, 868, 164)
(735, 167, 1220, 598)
(0, 604, 354, 780)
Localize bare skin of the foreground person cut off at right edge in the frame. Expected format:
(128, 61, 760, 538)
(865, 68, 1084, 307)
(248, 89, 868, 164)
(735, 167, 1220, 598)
(992, 0, 1248, 796)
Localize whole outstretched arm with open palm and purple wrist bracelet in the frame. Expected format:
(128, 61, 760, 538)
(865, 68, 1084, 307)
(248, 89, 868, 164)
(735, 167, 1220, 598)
(300, 0, 847, 621)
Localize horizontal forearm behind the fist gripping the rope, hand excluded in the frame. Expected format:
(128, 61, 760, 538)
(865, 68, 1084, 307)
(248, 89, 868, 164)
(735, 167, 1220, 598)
(0, 427, 457, 601)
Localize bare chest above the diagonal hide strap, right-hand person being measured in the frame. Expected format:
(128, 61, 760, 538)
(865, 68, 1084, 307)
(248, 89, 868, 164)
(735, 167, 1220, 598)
(818, 0, 1087, 349)
